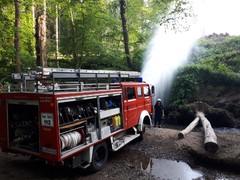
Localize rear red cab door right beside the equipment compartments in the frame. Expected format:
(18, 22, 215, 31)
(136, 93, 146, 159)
(124, 87, 138, 128)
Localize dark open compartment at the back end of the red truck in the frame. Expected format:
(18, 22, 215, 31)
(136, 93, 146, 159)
(8, 102, 39, 153)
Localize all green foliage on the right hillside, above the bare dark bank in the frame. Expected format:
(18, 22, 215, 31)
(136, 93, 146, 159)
(170, 34, 240, 106)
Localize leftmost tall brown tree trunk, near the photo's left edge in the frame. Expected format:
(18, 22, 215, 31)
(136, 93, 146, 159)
(14, 0, 21, 73)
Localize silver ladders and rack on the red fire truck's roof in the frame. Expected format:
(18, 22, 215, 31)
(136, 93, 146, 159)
(8, 67, 140, 92)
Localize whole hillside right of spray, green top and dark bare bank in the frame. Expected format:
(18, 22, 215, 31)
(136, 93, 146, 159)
(169, 34, 240, 127)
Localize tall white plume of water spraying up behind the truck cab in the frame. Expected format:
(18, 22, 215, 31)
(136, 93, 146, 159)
(142, 27, 198, 102)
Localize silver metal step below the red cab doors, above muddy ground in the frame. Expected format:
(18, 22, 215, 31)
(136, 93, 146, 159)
(112, 134, 140, 151)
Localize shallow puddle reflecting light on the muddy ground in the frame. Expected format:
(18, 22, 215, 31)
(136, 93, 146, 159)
(141, 158, 204, 180)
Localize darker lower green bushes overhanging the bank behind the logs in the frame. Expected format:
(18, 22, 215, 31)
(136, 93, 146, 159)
(170, 60, 240, 105)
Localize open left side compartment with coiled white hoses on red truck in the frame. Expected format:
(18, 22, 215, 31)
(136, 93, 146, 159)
(58, 98, 98, 153)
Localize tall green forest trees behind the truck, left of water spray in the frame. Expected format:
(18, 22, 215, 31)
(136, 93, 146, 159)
(0, 0, 187, 79)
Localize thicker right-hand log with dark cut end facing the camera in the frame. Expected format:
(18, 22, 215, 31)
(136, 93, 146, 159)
(197, 112, 219, 153)
